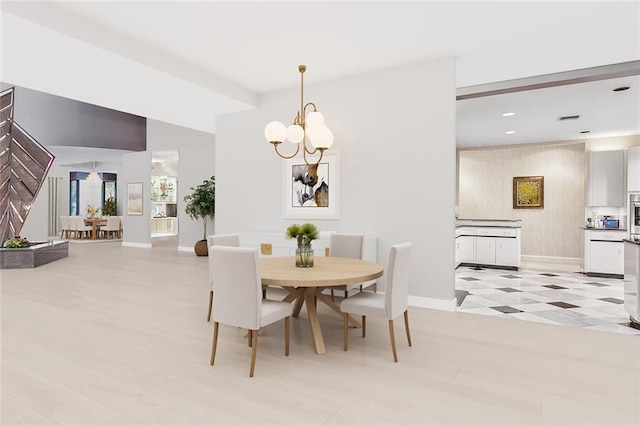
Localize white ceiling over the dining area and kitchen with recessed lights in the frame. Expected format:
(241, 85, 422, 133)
(1, 1, 640, 158)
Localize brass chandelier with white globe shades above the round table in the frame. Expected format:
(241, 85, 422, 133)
(264, 65, 333, 165)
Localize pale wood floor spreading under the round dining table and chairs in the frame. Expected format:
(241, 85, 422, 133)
(0, 240, 640, 425)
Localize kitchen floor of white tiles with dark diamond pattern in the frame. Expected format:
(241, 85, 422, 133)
(456, 266, 640, 336)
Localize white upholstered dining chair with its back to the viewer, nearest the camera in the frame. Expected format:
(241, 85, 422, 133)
(209, 245, 291, 377)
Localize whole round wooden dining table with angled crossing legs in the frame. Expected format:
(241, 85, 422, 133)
(260, 256, 384, 355)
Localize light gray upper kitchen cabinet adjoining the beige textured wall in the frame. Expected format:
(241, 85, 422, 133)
(587, 150, 625, 207)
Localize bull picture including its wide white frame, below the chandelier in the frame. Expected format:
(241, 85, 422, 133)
(283, 154, 340, 219)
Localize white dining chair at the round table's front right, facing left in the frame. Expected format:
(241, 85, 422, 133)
(340, 242, 411, 362)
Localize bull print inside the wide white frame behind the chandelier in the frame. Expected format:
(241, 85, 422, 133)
(291, 163, 330, 207)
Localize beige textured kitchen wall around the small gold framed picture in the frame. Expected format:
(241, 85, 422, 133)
(458, 143, 585, 258)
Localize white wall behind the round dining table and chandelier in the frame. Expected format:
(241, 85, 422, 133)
(216, 58, 456, 309)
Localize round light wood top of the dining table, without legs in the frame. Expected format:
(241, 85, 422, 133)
(260, 256, 384, 287)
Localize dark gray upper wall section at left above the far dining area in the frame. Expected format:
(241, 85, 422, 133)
(0, 82, 147, 151)
